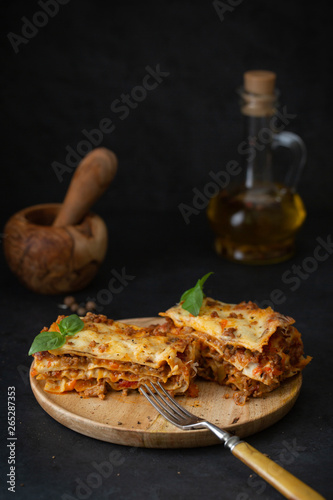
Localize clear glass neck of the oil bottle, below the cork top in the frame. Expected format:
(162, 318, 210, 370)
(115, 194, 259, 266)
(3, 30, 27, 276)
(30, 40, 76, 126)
(237, 91, 276, 189)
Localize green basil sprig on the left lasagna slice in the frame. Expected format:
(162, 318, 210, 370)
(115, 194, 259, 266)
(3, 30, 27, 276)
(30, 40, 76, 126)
(29, 314, 84, 356)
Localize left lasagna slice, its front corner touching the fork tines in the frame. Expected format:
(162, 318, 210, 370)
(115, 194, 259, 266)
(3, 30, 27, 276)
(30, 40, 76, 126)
(32, 313, 198, 399)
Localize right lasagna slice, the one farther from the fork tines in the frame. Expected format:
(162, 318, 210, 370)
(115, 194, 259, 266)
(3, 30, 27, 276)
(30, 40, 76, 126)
(160, 297, 311, 405)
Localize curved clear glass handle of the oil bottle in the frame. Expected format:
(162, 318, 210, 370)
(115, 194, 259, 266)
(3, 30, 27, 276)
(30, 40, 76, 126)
(272, 131, 307, 189)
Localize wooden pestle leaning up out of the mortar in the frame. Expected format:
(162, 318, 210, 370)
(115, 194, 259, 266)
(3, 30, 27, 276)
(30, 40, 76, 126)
(52, 148, 118, 227)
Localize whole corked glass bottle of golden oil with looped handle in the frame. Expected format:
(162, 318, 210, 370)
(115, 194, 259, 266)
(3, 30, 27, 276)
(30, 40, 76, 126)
(207, 71, 306, 264)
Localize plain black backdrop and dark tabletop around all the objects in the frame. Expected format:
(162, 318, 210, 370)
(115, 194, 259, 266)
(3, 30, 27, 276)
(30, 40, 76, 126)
(0, 0, 333, 500)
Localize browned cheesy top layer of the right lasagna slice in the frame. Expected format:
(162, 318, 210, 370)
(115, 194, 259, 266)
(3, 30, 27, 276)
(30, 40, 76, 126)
(160, 297, 294, 351)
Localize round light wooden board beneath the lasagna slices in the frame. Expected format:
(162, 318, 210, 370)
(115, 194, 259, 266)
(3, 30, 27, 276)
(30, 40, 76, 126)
(30, 318, 302, 448)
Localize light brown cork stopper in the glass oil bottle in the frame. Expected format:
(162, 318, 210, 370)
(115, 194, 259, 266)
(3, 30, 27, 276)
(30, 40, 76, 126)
(241, 70, 276, 117)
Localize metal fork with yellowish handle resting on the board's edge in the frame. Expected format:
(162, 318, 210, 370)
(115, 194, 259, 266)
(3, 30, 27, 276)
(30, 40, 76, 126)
(139, 382, 325, 500)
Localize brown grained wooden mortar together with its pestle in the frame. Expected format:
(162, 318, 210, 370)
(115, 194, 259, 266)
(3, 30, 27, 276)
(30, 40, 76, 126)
(4, 148, 117, 295)
